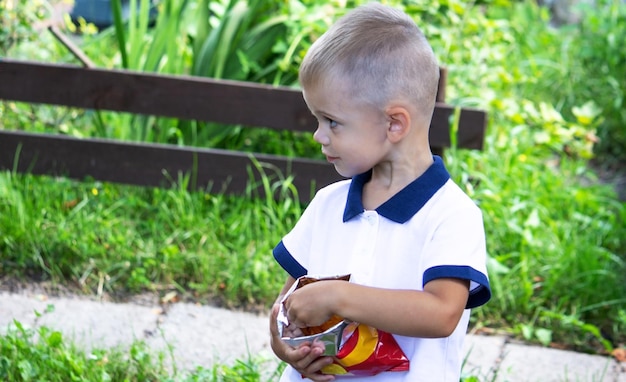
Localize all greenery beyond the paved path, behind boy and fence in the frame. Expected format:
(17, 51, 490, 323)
(0, 0, 626, 353)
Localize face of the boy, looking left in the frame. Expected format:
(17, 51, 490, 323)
(303, 80, 389, 178)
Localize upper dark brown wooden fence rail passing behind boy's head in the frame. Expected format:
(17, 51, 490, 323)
(0, 60, 486, 149)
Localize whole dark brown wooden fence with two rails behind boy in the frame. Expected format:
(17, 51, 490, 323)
(0, 59, 486, 201)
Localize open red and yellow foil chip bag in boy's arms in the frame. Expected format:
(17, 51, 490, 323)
(278, 275, 410, 376)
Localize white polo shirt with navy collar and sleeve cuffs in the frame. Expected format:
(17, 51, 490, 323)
(273, 156, 491, 382)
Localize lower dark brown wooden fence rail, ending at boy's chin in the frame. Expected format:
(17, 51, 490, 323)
(0, 131, 341, 201)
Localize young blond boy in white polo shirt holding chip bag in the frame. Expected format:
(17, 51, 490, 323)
(270, 3, 491, 382)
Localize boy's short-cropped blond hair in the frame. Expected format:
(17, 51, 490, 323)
(299, 3, 439, 120)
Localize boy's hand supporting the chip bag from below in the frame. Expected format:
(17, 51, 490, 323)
(270, 304, 335, 382)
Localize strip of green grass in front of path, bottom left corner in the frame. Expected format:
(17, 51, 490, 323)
(0, 321, 281, 382)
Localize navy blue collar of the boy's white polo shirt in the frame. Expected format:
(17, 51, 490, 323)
(343, 155, 450, 224)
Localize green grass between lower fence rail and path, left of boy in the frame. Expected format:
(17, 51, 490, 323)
(0, 160, 301, 308)
